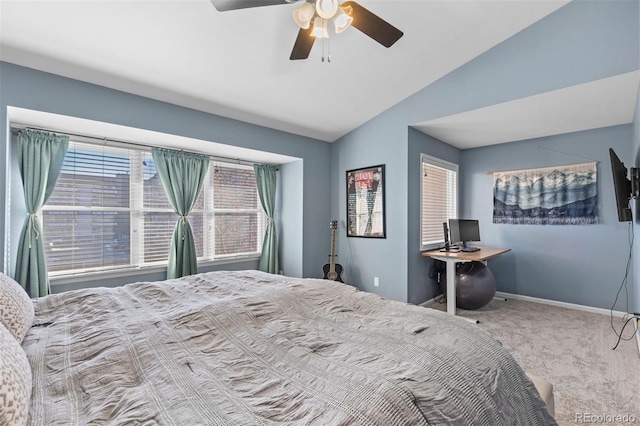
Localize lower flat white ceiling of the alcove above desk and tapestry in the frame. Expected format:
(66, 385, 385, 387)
(413, 71, 640, 149)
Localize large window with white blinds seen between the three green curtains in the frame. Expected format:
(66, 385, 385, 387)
(41, 142, 266, 275)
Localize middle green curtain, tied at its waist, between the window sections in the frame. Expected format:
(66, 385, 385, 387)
(151, 148, 209, 279)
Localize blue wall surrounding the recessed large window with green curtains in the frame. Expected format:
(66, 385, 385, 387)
(0, 62, 330, 284)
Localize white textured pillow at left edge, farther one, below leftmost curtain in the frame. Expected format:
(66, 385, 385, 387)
(0, 272, 34, 343)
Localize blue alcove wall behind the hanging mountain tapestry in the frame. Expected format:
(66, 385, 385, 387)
(460, 124, 633, 311)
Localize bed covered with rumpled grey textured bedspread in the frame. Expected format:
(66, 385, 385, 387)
(0, 271, 556, 426)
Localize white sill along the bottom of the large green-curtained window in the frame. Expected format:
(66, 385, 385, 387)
(49, 254, 260, 287)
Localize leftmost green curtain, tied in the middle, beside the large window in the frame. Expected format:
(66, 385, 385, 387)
(15, 130, 69, 297)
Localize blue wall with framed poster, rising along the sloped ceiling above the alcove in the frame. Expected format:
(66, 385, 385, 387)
(331, 0, 640, 305)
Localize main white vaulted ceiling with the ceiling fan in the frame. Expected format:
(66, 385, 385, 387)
(0, 0, 566, 142)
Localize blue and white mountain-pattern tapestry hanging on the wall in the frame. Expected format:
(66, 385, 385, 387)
(493, 162, 598, 225)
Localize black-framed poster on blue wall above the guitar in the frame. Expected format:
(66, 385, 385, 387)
(347, 164, 386, 238)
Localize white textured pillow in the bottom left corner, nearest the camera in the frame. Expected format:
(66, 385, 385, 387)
(0, 324, 31, 426)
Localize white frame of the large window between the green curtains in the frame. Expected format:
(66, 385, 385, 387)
(38, 138, 266, 285)
